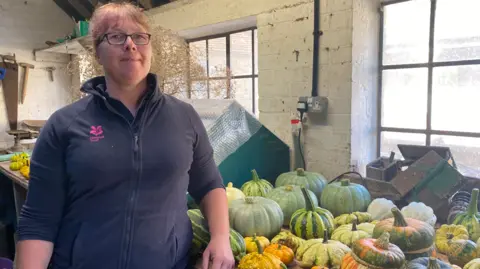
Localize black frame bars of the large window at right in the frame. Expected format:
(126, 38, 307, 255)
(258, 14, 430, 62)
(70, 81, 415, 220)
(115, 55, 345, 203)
(377, 0, 480, 157)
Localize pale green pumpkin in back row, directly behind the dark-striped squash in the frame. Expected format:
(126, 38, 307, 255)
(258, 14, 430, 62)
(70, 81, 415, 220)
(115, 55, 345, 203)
(275, 168, 327, 201)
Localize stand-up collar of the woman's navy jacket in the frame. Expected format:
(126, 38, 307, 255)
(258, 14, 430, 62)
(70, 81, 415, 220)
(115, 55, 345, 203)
(80, 73, 163, 101)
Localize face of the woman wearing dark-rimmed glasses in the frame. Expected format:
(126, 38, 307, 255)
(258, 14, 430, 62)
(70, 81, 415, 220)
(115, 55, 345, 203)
(97, 19, 152, 85)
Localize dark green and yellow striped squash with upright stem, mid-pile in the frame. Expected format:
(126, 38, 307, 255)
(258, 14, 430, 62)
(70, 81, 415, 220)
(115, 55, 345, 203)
(290, 187, 335, 239)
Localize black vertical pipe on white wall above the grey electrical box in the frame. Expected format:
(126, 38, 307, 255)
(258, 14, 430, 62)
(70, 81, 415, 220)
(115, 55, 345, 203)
(312, 0, 322, 96)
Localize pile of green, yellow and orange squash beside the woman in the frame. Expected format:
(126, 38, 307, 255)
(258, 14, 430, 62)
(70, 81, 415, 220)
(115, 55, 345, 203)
(191, 166, 480, 269)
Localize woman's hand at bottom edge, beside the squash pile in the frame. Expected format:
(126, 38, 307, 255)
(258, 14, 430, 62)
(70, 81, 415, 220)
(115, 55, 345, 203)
(202, 234, 235, 269)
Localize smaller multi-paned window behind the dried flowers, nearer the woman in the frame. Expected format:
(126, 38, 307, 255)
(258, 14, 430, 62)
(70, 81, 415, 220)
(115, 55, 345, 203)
(187, 29, 258, 114)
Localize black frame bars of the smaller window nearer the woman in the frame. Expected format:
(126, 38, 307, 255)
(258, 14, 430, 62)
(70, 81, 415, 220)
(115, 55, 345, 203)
(186, 27, 258, 115)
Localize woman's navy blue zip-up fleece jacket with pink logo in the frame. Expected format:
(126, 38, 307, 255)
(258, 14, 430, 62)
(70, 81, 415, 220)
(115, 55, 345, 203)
(18, 74, 224, 269)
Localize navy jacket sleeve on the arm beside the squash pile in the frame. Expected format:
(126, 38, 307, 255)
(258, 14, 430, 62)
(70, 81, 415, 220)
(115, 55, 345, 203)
(188, 105, 225, 204)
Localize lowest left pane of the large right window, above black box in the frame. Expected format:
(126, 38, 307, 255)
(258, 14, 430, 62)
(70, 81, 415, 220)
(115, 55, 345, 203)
(380, 132, 426, 159)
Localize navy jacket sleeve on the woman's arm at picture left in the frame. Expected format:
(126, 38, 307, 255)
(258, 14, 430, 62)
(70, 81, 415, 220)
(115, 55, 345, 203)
(18, 112, 66, 242)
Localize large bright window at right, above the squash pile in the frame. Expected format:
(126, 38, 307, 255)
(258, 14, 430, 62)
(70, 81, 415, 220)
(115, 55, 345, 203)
(378, 0, 480, 177)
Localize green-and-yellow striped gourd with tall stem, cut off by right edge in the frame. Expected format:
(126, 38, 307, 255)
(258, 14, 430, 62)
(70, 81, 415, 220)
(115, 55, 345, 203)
(453, 188, 480, 241)
